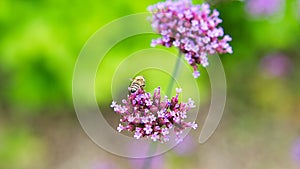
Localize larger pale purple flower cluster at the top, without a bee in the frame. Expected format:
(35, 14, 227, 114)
(148, 0, 233, 78)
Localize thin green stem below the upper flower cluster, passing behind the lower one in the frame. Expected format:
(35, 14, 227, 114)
(143, 51, 181, 169)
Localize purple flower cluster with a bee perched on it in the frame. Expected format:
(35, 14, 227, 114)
(111, 87, 197, 143)
